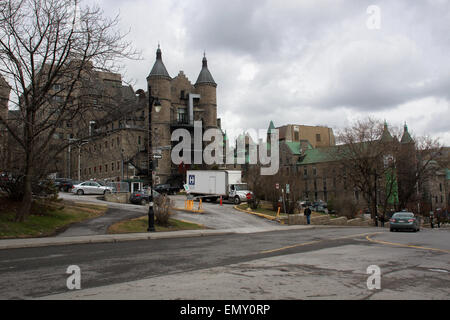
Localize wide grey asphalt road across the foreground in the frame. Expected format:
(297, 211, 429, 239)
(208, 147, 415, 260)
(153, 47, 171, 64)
(0, 227, 450, 299)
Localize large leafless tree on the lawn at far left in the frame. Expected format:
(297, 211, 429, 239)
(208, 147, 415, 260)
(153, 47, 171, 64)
(0, 0, 137, 221)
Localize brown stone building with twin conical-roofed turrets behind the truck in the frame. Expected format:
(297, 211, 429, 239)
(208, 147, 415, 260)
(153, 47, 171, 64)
(70, 47, 220, 184)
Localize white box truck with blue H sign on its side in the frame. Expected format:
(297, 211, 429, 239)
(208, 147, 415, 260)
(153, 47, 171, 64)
(186, 170, 253, 204)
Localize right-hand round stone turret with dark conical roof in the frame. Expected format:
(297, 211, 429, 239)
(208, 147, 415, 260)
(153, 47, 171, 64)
(194, 55, 217, 129)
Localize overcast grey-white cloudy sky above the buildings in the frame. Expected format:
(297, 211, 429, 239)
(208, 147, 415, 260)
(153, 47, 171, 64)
(88, 0, 450, 145)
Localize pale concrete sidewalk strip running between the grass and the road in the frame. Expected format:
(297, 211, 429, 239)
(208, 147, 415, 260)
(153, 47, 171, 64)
(0, 226, 318, 250)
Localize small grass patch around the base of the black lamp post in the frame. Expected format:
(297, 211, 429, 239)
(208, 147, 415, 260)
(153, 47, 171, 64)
(108, 215, 207, 233)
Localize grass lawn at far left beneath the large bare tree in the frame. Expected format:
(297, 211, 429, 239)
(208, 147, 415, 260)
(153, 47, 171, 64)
(0, 199, 106, 239)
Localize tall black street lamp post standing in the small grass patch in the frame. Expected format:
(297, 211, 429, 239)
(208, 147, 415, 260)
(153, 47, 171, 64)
(147, 86, 161, 232)
